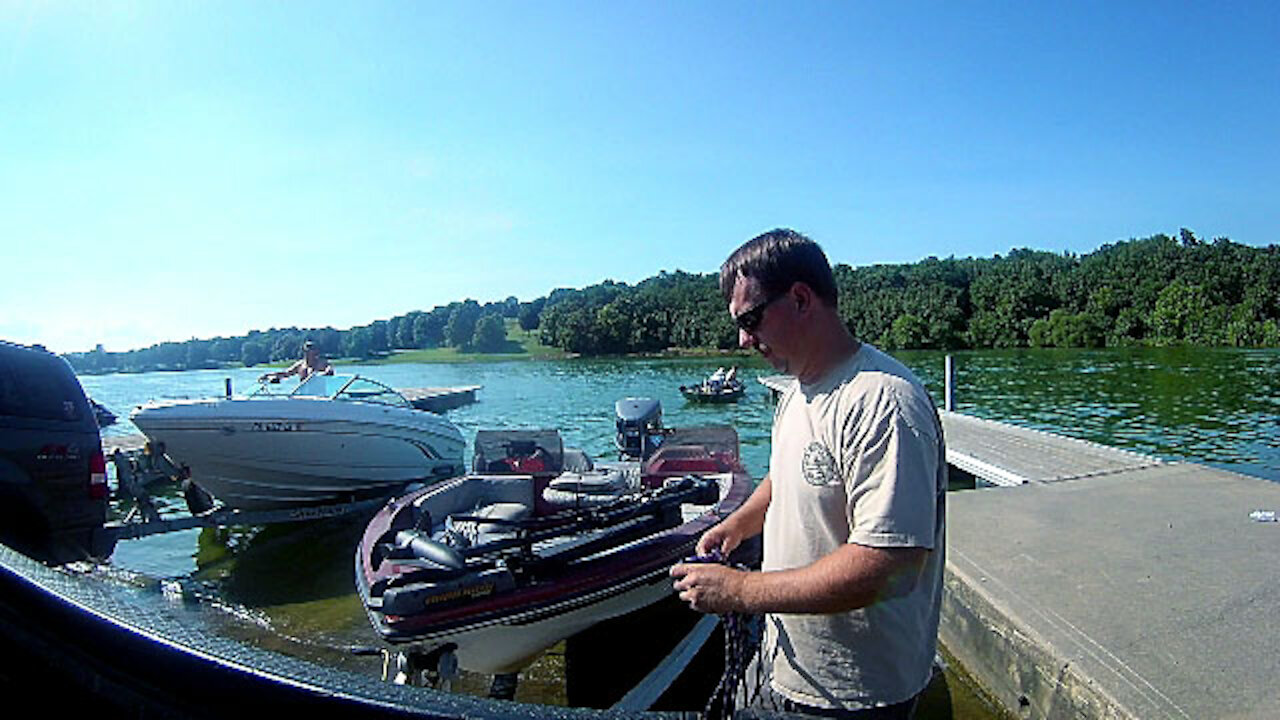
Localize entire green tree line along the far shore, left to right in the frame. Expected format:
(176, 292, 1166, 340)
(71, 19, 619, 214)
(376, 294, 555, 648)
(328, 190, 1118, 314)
(67, 229, 1280, 373)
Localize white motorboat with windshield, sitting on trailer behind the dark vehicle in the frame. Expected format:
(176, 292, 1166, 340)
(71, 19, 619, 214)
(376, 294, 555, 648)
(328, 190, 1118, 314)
(131, 375, 466, 510)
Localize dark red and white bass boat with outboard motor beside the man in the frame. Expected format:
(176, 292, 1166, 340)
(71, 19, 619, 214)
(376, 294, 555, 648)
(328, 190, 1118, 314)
(356, 398, 753, 683)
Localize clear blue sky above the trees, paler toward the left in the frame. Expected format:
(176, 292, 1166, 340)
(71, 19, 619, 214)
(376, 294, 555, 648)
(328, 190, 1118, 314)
(0, 0, 1280, 352)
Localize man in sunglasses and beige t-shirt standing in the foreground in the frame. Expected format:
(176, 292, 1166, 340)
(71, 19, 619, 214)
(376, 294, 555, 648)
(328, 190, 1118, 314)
(671, 229, 946, 719)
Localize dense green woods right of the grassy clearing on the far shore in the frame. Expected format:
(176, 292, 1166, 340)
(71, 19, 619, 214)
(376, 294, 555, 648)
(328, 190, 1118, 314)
(540, 229, 1280, 355)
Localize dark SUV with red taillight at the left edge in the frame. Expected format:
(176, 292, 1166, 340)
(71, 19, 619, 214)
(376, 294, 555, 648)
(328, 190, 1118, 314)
(0, 341, 110, 564)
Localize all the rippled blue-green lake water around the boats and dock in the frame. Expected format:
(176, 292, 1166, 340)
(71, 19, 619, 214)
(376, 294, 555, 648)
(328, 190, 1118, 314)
(72, 348, 1280, 717)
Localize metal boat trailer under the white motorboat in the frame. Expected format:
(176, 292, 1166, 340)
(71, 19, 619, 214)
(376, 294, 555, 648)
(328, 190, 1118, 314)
(101, 442, 387, 548)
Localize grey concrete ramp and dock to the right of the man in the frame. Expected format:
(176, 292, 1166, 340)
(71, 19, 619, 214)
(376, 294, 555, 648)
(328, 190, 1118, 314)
(765, 378, 1280, 720)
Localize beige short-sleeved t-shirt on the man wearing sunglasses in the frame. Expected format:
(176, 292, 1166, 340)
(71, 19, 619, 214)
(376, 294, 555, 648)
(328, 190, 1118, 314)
(763, 345, 947, 710)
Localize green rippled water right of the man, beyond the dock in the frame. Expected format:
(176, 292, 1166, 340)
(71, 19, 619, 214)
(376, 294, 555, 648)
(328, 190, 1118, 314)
(900, 348, 1280, 482)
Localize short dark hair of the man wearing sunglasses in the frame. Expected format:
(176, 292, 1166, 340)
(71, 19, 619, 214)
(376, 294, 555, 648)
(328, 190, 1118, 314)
(721, 228, 840, 307)
